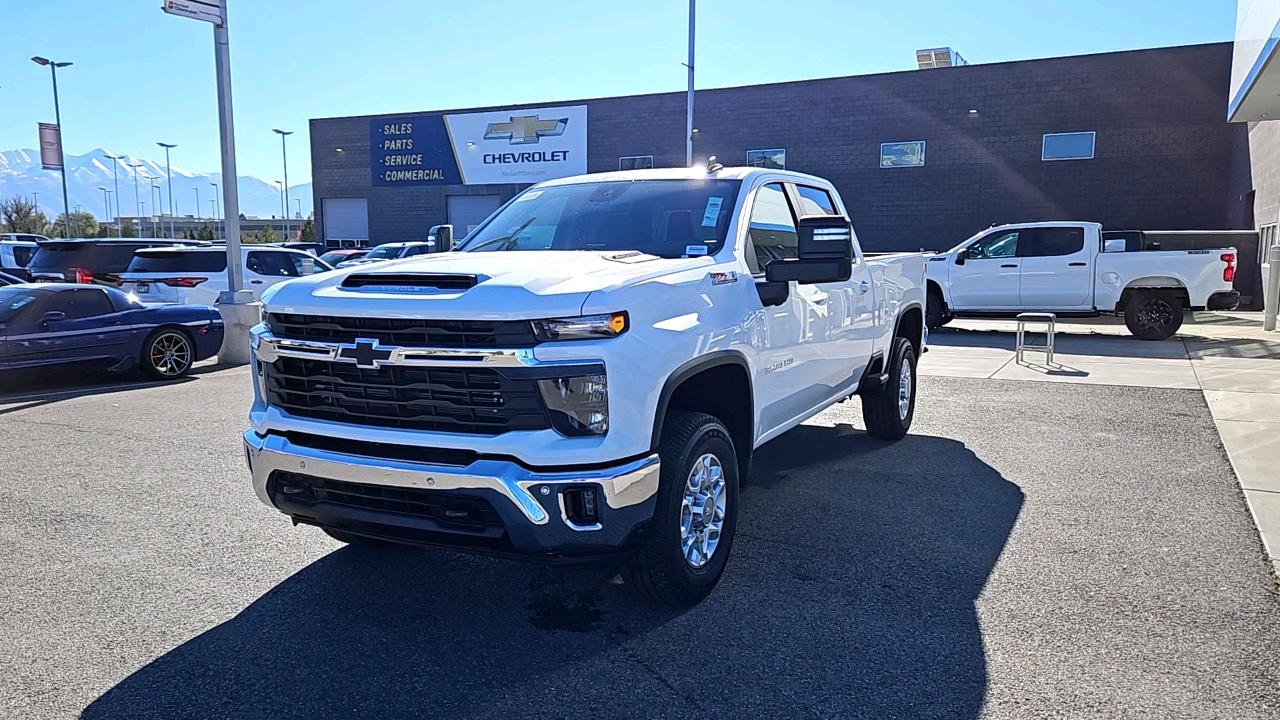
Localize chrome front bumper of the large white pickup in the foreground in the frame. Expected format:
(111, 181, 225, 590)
(244, 430, 660, 552)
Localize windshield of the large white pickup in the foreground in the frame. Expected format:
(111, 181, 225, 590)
(460, 179, 741, 258)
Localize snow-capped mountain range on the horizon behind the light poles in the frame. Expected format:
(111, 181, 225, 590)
(0, 149, 311, 220)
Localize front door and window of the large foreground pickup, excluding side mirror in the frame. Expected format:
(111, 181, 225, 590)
(746, 182, 831, 433)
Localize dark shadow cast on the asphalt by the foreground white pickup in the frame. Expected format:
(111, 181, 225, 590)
(82, 425, 1023, 720)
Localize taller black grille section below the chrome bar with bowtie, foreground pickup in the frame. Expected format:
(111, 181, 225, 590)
(264, 357, 550, 434)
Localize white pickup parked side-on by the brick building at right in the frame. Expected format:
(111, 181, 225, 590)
(927, 223, 1240, 340)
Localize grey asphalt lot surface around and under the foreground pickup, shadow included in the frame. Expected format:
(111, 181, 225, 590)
(0, 369, 1280, 720)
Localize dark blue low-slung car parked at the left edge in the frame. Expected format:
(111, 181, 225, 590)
(0, 283, 223, 379)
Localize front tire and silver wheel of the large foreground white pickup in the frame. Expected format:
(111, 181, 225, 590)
(623, 410, 739, 607)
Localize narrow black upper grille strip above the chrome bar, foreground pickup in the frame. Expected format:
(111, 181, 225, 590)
(268, 313, 538, 350)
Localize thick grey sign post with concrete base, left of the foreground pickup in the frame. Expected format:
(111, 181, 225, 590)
(163, 0, 260, 365)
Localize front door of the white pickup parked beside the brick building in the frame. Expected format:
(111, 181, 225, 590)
(950, 229, 1024, 310)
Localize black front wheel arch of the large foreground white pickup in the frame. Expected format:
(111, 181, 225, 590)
(649, 350, 755, 483)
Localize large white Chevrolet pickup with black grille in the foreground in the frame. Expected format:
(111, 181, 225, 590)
(243, 165, 927, 605)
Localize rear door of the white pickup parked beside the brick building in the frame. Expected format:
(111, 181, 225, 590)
(1018, 227, 1097, 310)
